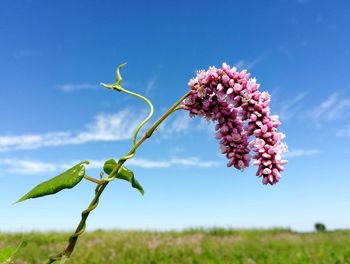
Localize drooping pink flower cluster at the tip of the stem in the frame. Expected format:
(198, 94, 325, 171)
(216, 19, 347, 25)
(183, 63, 287, 185)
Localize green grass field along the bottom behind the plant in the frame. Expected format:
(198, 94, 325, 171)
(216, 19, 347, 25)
(0, 228, 350, 264)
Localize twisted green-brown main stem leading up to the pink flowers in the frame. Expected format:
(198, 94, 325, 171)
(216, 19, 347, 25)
(45, 92, 190, 264)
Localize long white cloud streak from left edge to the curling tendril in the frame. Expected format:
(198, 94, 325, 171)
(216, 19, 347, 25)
(0, 110, 141, 152)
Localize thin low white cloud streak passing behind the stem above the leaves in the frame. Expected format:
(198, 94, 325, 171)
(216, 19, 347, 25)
(0, 157, 218, 174)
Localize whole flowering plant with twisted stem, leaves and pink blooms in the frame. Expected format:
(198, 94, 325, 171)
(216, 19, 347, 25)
(12, 63, 287, 263)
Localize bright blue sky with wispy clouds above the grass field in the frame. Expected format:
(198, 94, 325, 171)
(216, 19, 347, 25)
(0, 0, 350, 231)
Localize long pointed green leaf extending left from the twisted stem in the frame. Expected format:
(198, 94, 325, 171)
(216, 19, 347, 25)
(16, 161, 89, 203)
